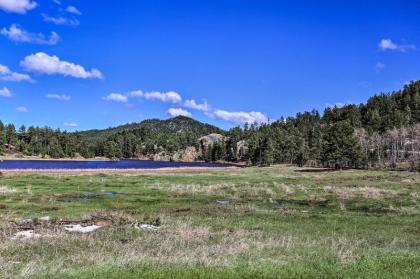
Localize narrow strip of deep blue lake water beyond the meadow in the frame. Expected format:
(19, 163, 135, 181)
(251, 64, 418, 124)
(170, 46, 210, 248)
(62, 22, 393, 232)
(0, 160, 236, 170)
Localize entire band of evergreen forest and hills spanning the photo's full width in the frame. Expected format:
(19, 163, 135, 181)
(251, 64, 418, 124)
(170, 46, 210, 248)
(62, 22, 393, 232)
(0, 81, 420, 170)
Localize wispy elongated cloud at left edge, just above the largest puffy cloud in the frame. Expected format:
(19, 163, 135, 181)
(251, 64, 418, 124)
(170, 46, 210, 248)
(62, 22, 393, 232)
(0, 24, 60, 45)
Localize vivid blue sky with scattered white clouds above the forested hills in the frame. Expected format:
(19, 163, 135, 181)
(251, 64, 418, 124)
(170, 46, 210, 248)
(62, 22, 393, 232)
(0, 0, 420, 130)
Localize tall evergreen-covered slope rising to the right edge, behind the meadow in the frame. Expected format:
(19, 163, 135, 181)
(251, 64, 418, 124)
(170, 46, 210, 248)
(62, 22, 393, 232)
(235, 81, 420, 169)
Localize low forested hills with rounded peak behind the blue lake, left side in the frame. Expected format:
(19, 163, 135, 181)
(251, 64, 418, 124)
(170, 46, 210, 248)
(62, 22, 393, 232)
(0, 116, 225, 158)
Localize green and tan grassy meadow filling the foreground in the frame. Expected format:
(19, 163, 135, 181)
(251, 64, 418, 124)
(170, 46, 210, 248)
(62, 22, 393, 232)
(0, 166, 420, 278)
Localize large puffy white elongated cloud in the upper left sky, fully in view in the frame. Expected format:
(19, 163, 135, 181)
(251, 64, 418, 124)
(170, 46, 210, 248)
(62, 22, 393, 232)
(20, 52, 103, 79)
